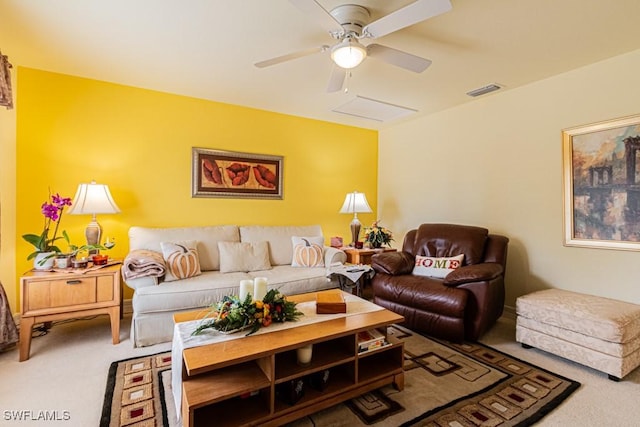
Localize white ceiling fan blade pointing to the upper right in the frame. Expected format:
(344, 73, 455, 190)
(362, 0, 451, 39)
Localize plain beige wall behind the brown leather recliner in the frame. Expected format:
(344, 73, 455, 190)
(378, 50, 640, 306)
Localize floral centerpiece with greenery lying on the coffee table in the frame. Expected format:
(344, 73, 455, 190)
(192, 289, 303, 335)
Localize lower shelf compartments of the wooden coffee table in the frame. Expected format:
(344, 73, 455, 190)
(182, 343, 404, 426)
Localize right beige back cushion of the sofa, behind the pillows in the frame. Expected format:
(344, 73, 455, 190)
(240, 225, 322, 266)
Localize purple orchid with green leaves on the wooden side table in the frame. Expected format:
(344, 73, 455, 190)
(22, 193, 71, 266)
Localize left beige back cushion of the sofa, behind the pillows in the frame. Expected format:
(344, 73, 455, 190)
(129, 225, 240, 271)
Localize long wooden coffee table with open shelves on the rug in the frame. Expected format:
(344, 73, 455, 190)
(174, 292, 404, 426)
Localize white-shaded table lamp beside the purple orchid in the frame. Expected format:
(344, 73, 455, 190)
(69, 181, 120, 245)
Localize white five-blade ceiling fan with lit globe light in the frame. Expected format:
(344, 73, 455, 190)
(255, 0, 451, 92)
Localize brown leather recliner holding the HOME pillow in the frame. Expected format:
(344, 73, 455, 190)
(371, 224, 509, 342)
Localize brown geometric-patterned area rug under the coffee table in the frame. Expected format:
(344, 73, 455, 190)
(100, 325, 580, 427)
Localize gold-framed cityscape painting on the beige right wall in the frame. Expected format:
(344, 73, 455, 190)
(562, 115, 640, 251)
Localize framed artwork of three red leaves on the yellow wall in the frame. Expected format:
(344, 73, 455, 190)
(191, 147, 282, 199)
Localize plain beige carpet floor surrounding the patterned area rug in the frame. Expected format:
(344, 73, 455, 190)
(0, 314, 640, 427)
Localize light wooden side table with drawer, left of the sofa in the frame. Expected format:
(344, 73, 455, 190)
(20, 265, 122, 362)
